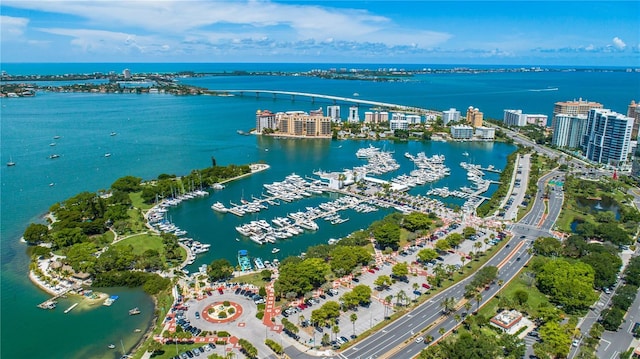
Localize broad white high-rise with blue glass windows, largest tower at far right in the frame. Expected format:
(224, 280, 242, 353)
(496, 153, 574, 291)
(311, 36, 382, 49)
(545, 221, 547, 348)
(582, 108, 633, 167)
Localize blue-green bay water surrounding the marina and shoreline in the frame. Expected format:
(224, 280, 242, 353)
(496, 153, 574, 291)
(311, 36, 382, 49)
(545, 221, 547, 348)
(0, 64, 640, 358)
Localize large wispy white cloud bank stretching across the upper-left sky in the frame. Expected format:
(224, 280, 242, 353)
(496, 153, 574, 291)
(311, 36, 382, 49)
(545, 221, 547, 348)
(3, 0, 451, 47)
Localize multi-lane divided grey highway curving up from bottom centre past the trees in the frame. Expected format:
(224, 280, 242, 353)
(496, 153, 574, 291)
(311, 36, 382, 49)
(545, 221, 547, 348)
(340, 172, 563, 359)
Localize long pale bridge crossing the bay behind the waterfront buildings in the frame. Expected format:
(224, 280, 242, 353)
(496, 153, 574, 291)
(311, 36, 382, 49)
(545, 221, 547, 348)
(209, 90, 442, 116)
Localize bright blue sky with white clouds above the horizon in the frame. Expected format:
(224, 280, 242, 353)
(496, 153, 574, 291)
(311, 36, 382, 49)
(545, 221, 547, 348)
(0, 0, 640, 67)
